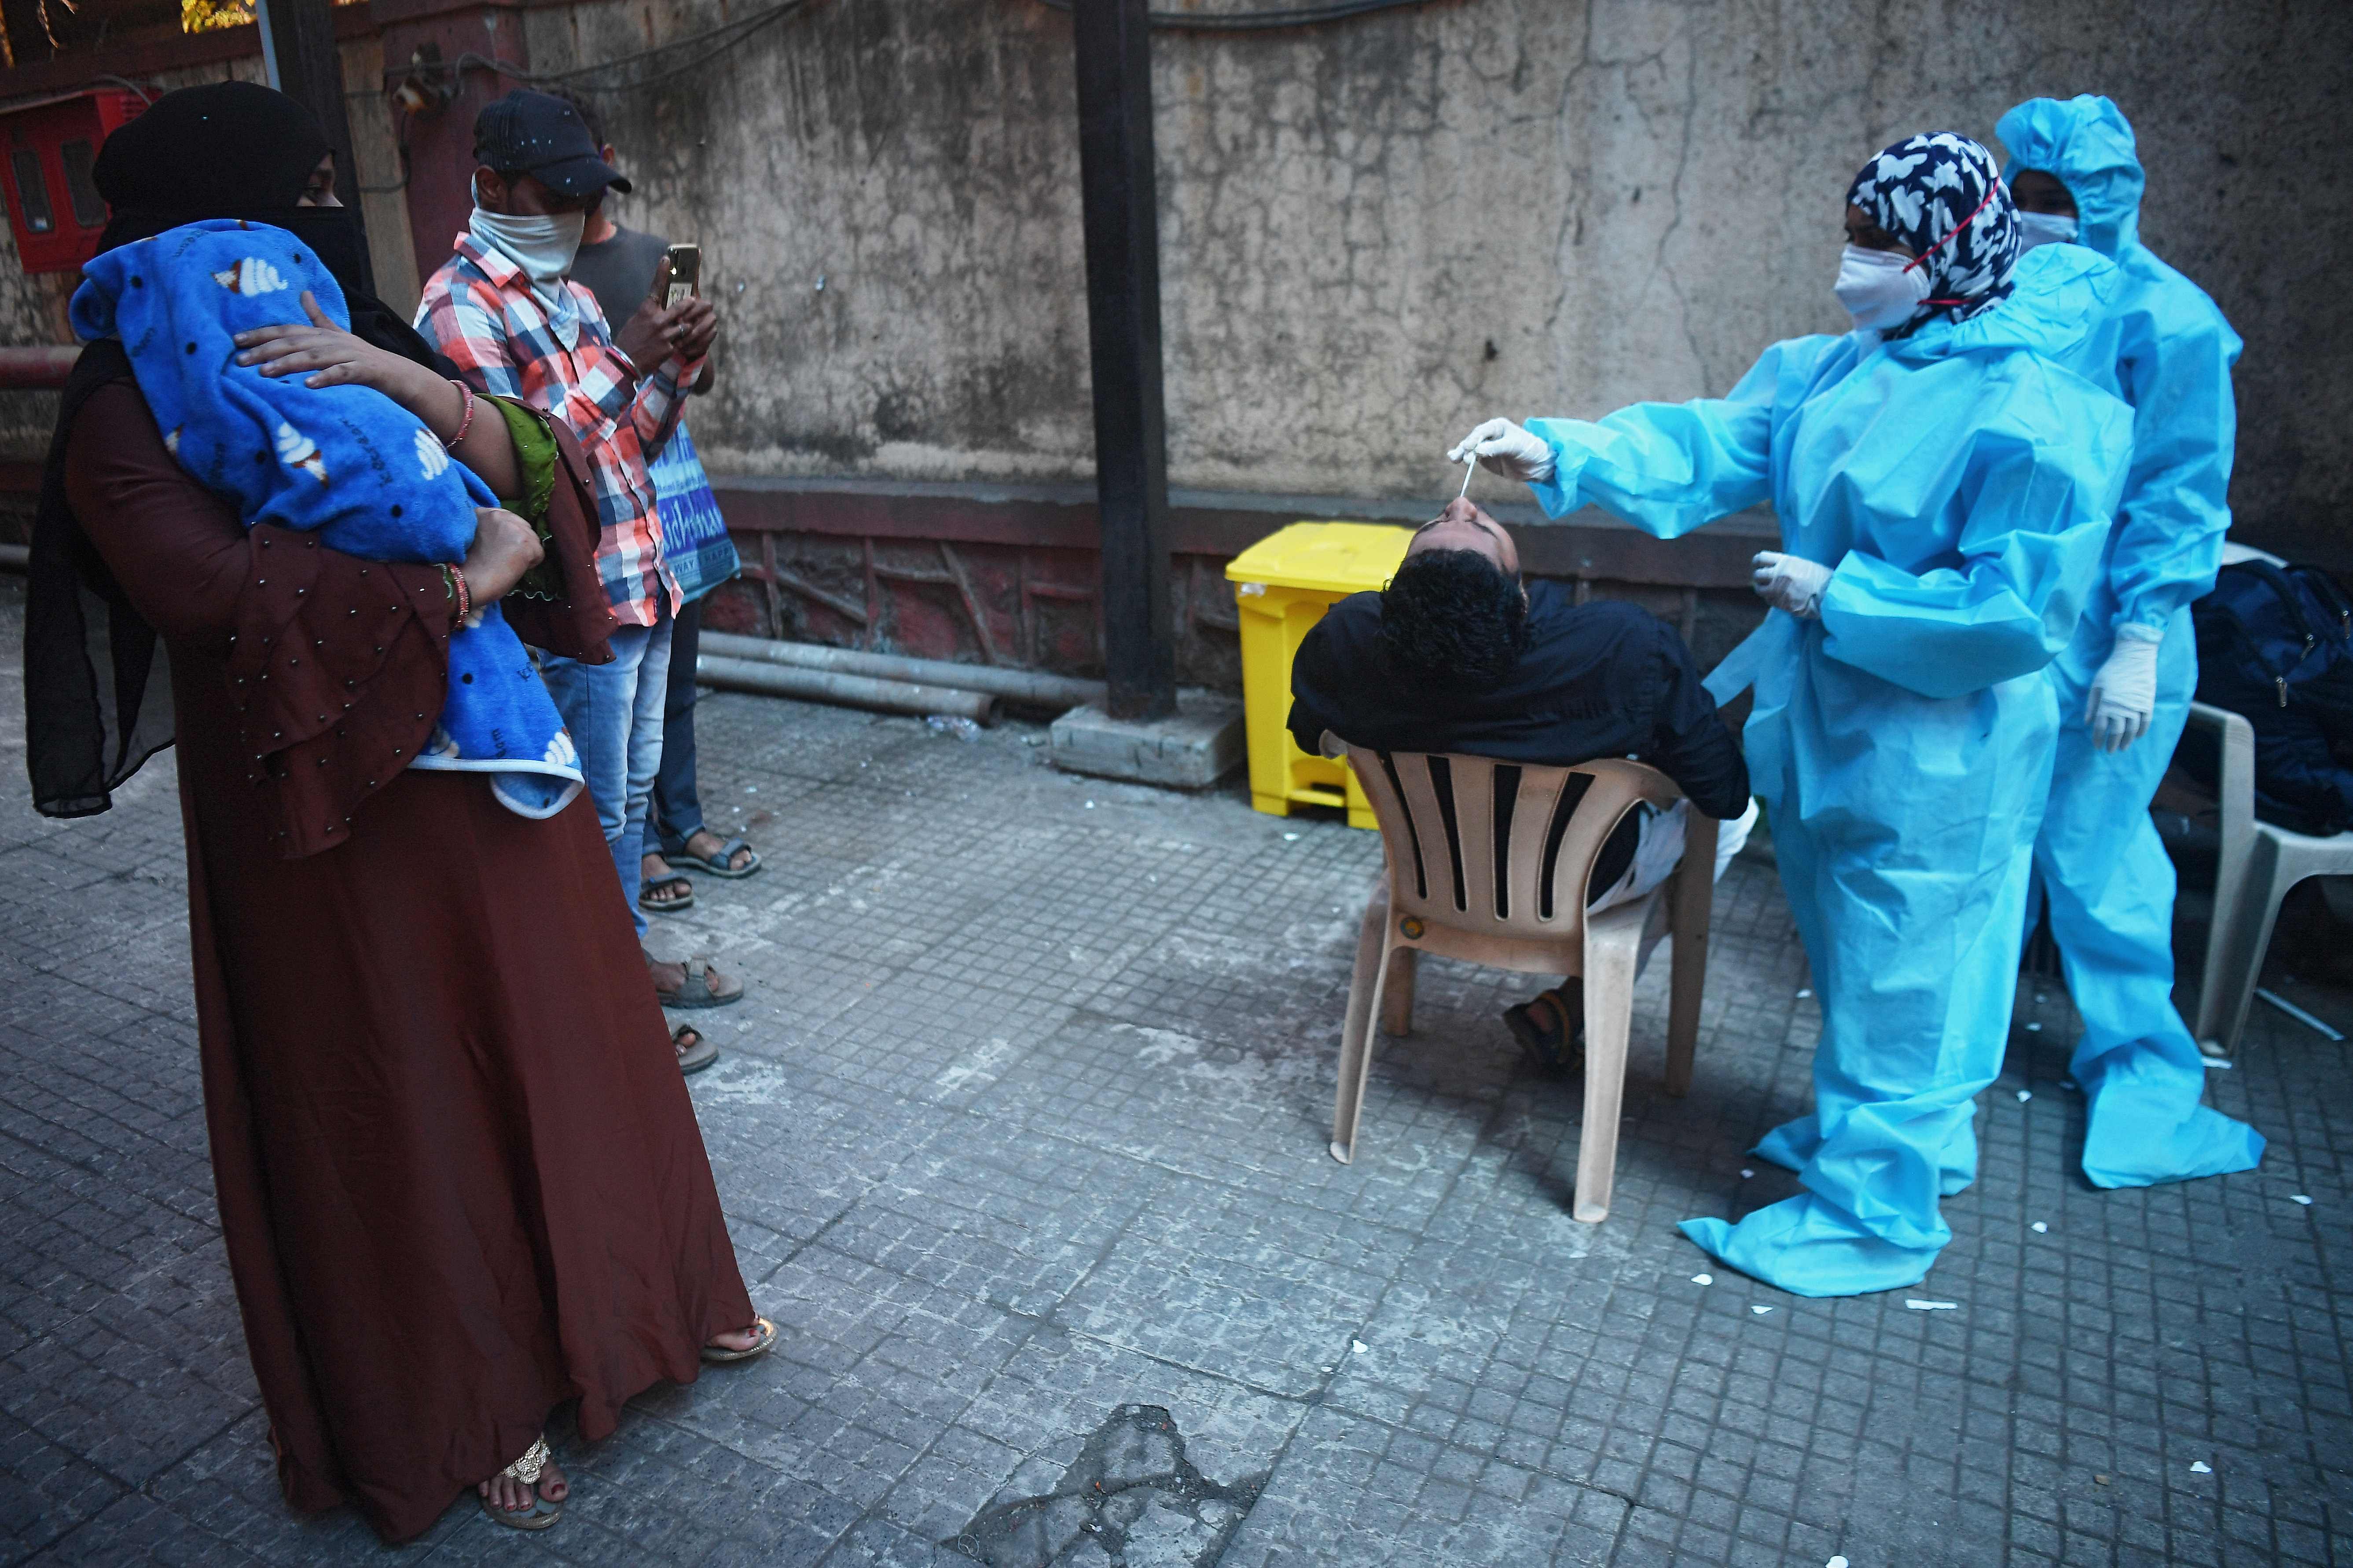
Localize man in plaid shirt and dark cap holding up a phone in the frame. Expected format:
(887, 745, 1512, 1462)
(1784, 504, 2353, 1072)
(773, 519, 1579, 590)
(416, 92, 744, 1044)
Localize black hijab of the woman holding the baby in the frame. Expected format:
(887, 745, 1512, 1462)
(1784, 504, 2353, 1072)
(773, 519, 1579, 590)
(23, 82, 454, 816)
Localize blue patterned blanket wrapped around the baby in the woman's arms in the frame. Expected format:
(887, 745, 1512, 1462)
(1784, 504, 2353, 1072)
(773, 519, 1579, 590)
(73, 219, 581, 816)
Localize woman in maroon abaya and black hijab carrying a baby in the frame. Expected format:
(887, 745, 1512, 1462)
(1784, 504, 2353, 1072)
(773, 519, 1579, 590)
(26, 82, 777, 1540)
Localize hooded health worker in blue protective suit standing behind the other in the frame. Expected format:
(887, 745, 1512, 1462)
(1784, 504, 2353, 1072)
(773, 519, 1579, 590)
(1998, 96, 2264, 1187)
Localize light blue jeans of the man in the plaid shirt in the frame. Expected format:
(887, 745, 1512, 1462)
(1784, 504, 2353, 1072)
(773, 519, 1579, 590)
(539, 614, 671, 938)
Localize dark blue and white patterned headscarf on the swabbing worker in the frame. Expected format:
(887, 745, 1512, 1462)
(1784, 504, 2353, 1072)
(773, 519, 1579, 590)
(1847, 132, 2019, 320)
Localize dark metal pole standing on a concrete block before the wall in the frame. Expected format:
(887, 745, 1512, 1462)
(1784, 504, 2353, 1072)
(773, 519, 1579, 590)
(1073, 0, 1177, 719)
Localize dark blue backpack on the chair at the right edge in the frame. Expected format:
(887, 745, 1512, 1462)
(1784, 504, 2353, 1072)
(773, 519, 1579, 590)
(2191, 562, 2353, 835)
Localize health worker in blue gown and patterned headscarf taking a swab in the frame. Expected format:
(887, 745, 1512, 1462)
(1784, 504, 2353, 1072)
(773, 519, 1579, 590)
(1457, 132, 2132, 1295)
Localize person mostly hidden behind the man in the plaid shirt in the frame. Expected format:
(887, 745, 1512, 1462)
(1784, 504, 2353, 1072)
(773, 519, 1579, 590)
(562, 94, 760, 949)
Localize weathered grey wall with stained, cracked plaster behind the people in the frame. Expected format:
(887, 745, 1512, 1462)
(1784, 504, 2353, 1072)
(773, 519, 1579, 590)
(529, 0, 2353, 564)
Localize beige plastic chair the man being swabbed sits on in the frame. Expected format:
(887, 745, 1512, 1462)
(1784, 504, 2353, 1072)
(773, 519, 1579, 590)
(1332, 745, 1715, 1225)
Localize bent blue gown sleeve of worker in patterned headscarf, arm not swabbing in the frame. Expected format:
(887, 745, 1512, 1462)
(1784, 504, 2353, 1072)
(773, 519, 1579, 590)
(1821, 362, 2132, 698)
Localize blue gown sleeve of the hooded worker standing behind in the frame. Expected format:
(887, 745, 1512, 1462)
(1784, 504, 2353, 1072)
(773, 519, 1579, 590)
(2108, 289, 2240, 632)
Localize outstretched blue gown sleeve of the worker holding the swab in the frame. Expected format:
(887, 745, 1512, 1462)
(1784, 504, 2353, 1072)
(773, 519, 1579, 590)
(1527, 336, 1843, 539)
